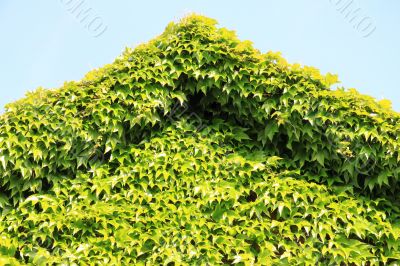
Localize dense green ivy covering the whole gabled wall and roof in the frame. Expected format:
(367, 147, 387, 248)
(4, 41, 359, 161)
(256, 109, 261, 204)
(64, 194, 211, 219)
(0, 15, 400, 265)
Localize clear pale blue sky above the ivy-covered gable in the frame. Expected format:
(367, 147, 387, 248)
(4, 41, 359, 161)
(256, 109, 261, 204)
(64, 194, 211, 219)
(0, 0, 400, 112)
